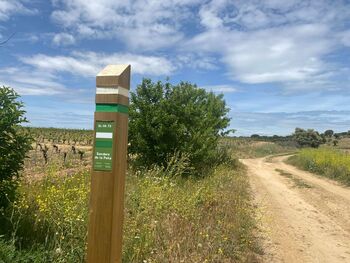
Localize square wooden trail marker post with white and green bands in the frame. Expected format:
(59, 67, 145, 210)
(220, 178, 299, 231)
(87, 65, 130, 263)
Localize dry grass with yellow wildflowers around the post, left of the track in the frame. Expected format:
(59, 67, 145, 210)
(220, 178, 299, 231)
(0, 160, 259, 263)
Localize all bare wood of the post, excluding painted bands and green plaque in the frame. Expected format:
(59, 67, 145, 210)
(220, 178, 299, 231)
(86, 65, 131, 263)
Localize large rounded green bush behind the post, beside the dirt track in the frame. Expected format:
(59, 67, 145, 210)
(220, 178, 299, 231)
(129, 79, 230, 171)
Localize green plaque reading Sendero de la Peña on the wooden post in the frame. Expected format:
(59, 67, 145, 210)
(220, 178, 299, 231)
(94, 121, 115, 171)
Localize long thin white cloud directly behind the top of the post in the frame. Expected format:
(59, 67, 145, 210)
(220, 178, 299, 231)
(19, 52, 175, 77)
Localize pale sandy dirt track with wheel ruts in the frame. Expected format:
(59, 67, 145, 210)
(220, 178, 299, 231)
(241, 157, 350, 263)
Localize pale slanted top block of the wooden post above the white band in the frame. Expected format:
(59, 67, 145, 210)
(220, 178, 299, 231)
(96, 65, 130, 89)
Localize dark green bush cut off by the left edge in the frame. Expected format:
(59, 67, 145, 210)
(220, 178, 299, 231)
(0, 87, 32, 210)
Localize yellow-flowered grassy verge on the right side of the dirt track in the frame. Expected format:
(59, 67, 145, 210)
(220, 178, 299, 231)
(287, 148, 350, 186)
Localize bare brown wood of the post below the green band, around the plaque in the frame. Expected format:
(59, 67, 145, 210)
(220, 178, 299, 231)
(87, 112, 128, 263)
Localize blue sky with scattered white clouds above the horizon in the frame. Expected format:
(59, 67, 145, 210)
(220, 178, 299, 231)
(0, 0, 350, 135)
